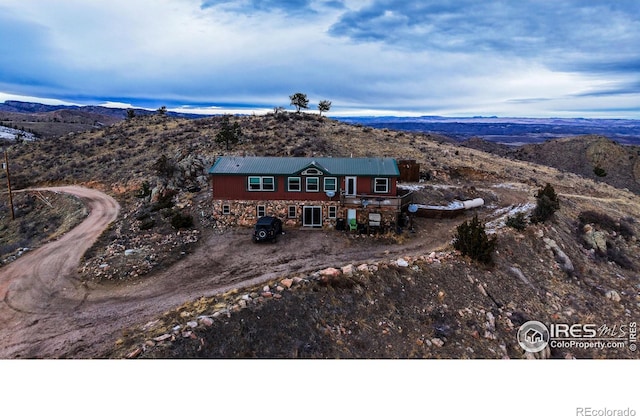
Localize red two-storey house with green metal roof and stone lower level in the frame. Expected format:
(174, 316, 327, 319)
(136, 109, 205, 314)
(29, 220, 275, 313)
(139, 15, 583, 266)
(209, 156, 411, 229)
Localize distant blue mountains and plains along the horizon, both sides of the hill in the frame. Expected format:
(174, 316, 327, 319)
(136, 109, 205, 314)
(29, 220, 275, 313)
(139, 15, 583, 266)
(5, 101, 640, 146)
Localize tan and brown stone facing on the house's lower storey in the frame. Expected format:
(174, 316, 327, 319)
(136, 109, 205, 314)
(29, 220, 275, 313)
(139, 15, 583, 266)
(213, 200, 397, 228)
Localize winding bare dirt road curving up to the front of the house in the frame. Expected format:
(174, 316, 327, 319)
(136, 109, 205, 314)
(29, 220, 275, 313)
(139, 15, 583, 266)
(0, 187, 460, 358)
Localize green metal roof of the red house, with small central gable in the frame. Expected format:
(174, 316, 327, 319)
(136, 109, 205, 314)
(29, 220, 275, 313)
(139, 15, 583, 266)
(209, 156, 400, 176)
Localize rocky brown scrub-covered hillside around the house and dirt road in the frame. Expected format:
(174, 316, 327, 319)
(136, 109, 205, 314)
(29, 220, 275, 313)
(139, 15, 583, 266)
(2, 113, 640, 358)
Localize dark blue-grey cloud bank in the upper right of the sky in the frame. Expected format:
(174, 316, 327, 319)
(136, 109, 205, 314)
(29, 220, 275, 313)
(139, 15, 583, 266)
(329, 0, 640, 69)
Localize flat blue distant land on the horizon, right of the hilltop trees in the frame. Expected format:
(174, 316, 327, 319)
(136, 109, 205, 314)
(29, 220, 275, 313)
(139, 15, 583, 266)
(334, 116, 640, 145)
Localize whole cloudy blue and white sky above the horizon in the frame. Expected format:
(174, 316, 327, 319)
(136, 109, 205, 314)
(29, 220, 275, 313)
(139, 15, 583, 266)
(0, 0, 640, 118)
